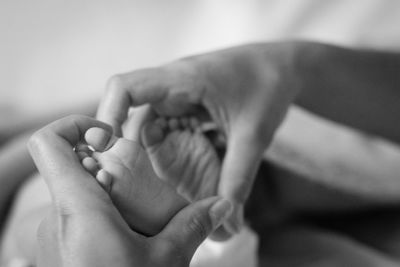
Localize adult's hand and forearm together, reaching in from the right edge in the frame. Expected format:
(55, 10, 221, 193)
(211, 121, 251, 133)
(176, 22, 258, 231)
(98, 42, 400, 239)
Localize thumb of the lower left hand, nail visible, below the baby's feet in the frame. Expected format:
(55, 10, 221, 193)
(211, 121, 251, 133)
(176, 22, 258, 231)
(158, 197, 232, 260)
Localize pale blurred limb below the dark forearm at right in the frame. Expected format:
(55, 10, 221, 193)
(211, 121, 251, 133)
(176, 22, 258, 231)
(265, 109, 400, 205)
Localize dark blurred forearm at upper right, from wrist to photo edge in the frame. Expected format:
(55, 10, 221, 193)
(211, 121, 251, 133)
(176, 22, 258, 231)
(296, 43, 400, 143)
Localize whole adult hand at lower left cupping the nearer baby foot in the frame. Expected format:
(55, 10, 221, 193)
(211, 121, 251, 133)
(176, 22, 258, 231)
(29, 116, 233, 267)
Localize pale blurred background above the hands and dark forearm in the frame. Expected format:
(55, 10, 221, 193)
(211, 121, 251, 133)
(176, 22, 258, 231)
(0, 0, 400, 114)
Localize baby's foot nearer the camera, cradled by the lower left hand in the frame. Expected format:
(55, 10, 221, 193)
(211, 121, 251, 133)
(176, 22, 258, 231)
(78, 128, 188, 235)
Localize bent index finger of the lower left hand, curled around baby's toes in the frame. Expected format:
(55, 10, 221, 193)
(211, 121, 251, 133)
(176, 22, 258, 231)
(28, 116, 111, 213)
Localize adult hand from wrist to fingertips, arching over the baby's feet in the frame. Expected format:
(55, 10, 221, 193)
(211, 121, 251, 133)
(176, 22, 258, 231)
(98, 43, 297, 239)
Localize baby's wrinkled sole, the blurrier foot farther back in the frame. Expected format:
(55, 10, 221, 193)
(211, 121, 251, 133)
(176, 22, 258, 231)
(142, 118, 221, 201)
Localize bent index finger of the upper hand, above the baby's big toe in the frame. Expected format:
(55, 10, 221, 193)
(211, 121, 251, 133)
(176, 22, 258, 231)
(97, 68, 168, 136)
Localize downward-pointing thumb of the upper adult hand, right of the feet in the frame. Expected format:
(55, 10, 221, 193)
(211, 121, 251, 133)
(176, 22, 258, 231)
(218, 129, 264, 234)
